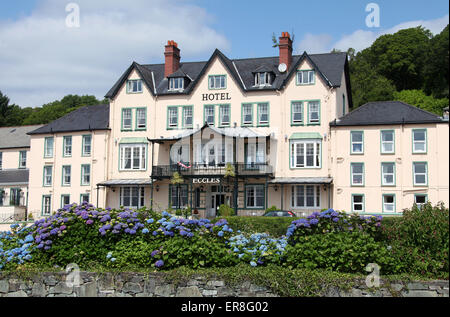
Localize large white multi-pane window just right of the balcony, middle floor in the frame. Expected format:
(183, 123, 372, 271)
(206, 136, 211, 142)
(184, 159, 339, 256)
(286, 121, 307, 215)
(291, 140, 321, 168)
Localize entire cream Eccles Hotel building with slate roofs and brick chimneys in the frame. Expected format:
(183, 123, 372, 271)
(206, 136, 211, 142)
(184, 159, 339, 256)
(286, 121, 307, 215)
(8, 33, 449, 217)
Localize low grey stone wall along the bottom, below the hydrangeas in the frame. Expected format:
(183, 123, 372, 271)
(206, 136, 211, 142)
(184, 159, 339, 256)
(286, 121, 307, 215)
(0, 272, 449, 297)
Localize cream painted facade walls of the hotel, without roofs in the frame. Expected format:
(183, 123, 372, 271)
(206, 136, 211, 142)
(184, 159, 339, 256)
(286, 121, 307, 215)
(22, 34, 449, 217)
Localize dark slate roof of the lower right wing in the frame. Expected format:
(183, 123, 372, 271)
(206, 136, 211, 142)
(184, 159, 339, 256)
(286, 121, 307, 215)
(330, 101, 448, 126)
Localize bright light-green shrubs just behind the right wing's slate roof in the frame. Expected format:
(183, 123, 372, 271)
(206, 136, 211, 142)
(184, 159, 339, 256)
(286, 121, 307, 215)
(394, 90, 448, 116)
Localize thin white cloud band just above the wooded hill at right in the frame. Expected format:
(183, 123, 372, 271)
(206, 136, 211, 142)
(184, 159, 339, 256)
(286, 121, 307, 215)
(297, 14, 449, 53)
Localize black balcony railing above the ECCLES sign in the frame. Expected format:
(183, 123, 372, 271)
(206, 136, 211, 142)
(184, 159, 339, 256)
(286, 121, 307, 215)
(152, 163, 272, 178)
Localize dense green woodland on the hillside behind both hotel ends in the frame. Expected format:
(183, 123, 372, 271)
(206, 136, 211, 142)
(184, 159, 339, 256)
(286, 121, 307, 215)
(0, 25, 449, 127)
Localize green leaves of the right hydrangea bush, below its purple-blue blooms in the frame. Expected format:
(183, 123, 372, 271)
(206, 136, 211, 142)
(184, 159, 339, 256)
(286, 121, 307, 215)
(284, 231, 395, 274)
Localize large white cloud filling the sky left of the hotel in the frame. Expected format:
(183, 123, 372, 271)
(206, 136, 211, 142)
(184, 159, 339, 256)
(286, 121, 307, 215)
(0, 0, 230, 107)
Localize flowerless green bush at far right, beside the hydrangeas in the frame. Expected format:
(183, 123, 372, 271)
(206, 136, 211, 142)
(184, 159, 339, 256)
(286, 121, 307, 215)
(383, 203, 449, 277)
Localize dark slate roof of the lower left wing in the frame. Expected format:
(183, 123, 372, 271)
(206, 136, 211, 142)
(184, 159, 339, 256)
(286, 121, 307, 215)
(28, 104, 109, 135)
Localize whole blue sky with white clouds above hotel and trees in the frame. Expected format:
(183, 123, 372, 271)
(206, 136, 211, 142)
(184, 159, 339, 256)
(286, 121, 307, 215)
(0, 0, 449, 107)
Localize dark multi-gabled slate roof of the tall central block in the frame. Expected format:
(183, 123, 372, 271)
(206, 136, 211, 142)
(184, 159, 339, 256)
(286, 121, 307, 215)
(105, 49, 351, 99)
